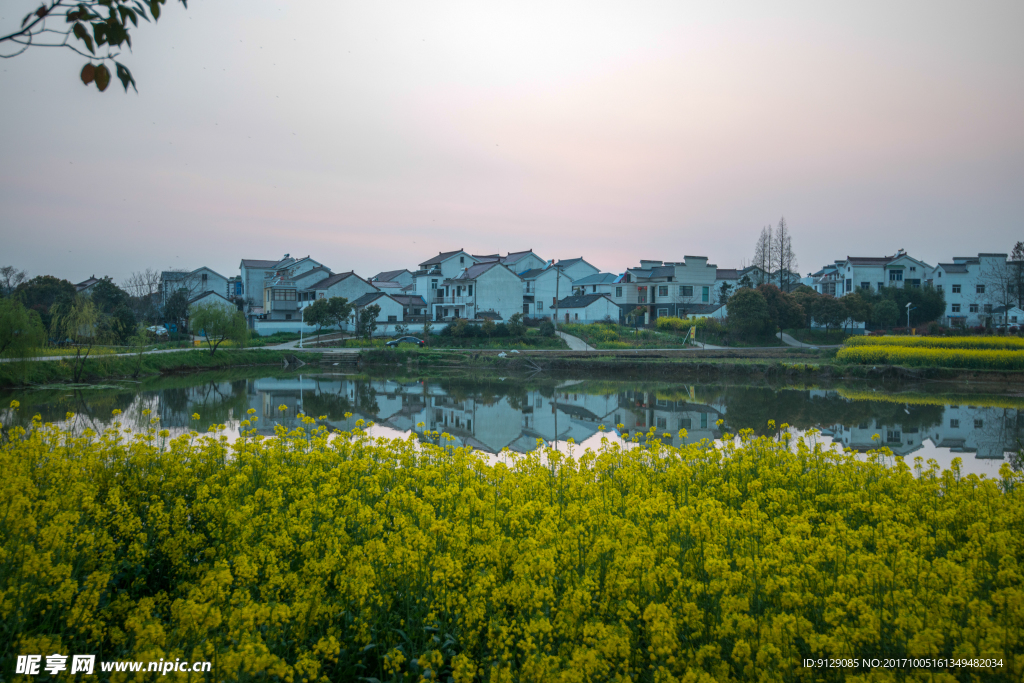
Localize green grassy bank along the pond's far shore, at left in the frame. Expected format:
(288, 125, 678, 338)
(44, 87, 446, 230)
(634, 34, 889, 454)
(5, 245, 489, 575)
(0, 349, 318, 387)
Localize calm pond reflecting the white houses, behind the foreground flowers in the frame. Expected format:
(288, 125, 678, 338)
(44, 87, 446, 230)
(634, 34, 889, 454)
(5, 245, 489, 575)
(0, 369, 1024, 476)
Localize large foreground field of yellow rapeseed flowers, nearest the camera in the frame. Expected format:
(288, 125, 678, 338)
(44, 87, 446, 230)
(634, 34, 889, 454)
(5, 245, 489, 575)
(0, 403, 1024, 683)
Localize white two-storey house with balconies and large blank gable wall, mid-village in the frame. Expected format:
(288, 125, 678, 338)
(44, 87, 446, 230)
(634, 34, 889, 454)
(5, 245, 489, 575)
(426, 261, 522, 321)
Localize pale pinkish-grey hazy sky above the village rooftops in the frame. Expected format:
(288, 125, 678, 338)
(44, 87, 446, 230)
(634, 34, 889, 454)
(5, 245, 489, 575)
(0, 0, 1024, 283)
